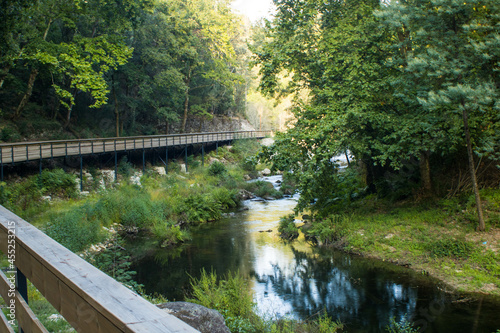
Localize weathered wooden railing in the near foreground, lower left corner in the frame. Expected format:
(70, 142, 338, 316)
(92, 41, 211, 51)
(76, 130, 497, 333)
(0, 206, 198, 333)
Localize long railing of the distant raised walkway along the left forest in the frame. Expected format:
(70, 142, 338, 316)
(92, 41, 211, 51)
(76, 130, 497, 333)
(0, 131, 270, 166)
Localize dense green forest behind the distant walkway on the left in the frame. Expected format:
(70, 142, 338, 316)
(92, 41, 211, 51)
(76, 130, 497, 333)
(0, 0, 278, 141)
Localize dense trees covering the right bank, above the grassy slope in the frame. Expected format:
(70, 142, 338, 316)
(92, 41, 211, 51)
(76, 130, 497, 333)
(254, 0, 500, 230)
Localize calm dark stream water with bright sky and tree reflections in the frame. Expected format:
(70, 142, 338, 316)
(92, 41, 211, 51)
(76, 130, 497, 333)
(134, 177, 500, 333)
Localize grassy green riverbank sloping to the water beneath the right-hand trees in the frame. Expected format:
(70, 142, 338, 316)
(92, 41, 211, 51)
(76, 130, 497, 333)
(303, 190, 500, 295)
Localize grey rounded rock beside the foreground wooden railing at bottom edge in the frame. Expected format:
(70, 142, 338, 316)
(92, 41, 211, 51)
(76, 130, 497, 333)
(157, 302, 231, 333)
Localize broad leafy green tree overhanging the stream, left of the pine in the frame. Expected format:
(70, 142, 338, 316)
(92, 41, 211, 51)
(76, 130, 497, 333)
(256, 0, 400, 211)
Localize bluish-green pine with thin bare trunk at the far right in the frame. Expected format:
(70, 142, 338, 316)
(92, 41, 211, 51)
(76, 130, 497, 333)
(378, 0, 500, 230)
